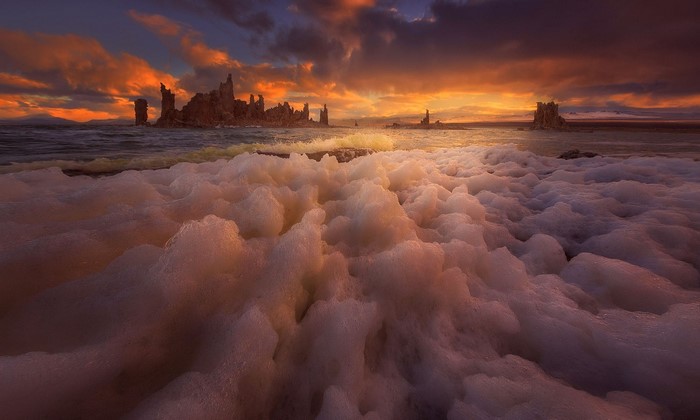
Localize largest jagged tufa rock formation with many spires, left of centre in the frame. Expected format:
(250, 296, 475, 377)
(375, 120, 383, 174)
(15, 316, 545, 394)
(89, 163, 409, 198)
(156, 74, 328, 127)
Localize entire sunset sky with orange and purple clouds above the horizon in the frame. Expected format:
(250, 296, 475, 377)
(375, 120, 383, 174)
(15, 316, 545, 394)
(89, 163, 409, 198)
(0, 0, 700, 122)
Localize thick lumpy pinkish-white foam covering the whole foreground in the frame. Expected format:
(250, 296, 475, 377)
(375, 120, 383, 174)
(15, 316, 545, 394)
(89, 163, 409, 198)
(0, 144, 700, 419)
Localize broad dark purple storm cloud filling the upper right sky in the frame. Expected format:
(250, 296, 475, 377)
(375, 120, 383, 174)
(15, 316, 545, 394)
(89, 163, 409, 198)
(271, 0, 700, 103)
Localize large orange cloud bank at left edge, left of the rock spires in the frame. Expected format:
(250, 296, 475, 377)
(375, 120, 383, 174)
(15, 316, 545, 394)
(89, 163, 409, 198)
(0, 29, 183, 121)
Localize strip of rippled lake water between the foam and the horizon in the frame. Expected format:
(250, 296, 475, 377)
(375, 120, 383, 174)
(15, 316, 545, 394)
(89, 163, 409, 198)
(0, 126, 700, 173)
